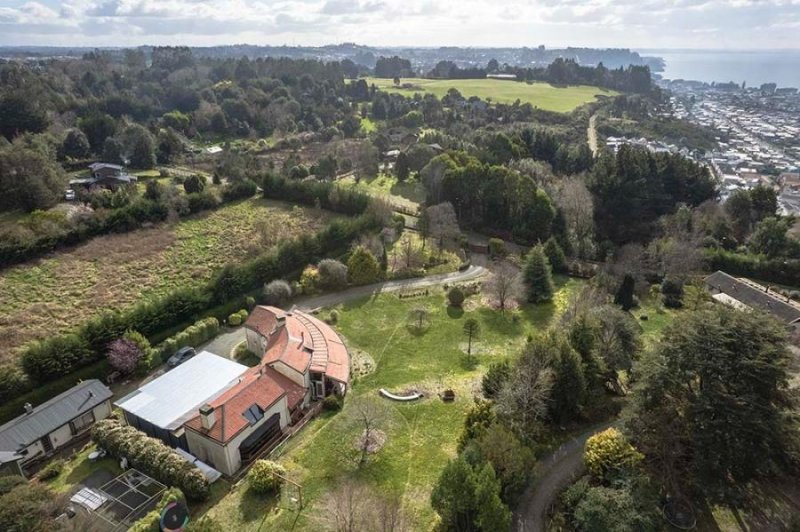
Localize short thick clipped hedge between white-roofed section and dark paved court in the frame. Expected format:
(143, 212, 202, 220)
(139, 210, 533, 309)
(92, 418, 209, 501)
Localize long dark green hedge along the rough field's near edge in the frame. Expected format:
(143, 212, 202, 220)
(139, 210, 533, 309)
(11, 215, 376, 396)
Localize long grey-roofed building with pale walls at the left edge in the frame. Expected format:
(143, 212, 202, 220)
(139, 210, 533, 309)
(0, 379, 112, 474)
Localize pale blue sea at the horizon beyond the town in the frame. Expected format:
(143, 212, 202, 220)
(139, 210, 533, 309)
(639, 50, 800, 88)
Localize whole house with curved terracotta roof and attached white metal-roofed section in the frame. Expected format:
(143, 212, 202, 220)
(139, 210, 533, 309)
(115, 306, 350, 475)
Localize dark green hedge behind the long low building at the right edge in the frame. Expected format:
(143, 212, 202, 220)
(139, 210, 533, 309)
(706, 249, 800, 287)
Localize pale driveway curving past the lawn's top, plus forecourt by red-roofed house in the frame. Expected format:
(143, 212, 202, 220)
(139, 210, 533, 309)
(201, 266, 487, 358)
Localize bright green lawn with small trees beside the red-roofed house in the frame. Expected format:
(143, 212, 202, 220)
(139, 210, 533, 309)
(203, 278, 582, 531)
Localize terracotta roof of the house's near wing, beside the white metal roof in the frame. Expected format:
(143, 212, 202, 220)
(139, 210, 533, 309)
(186, 366, 305, 443)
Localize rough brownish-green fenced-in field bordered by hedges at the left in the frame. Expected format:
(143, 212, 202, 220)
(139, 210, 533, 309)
(0, 198, 331, 360)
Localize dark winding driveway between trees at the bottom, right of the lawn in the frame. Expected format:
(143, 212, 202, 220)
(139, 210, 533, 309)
(513, 423, 611, 532)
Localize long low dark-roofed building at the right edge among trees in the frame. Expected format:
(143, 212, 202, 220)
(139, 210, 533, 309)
(706, 271, 800, 331)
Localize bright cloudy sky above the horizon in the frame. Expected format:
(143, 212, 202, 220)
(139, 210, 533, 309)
(0, 0, 800, 49)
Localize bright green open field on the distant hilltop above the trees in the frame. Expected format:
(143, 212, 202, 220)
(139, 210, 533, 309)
(366, 78, 619, 113)
